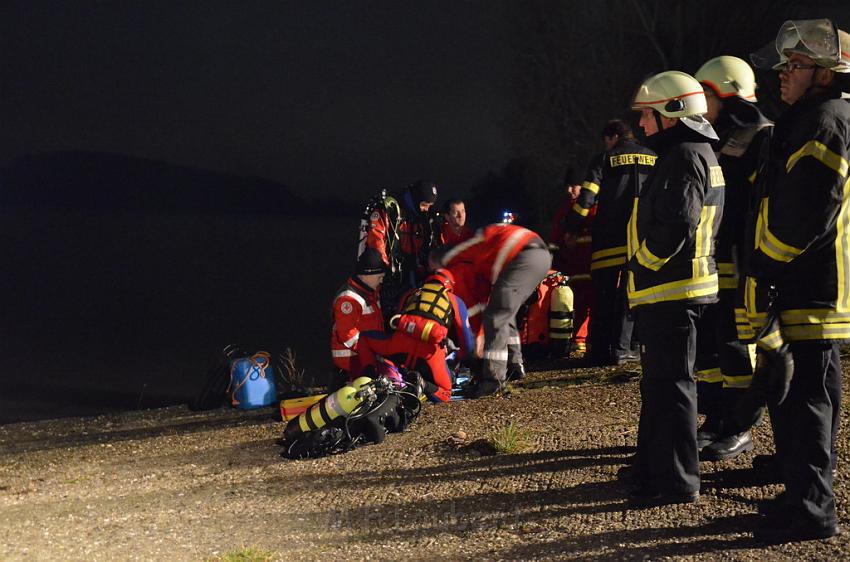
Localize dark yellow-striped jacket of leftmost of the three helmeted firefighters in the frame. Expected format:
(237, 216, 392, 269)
(627, 123, 724, 309)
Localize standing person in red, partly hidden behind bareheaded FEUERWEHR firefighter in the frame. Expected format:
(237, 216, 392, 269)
(549, 171, 597, 353)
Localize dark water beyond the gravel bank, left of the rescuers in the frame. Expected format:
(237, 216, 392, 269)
(0, 210, 357, 423)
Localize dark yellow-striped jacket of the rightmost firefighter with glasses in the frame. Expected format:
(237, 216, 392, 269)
(745, 93, 850, 341)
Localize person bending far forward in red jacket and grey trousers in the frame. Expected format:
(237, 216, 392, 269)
(430, 223, 552, 398)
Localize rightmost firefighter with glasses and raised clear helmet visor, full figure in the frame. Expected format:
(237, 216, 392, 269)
(745, 19, 850, 541)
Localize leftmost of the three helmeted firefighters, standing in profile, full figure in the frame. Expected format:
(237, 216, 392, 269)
(627, 71, 724, 507)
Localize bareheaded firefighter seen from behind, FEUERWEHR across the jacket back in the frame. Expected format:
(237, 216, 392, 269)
(566, 119, 656, 365)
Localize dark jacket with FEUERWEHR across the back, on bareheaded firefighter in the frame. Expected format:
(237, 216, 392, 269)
(565, 139, 656, 271)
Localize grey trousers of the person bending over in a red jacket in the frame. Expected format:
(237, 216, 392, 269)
(481, 246, 552, 383)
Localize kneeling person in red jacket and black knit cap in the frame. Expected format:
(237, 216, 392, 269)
(331, 248, 386, 378)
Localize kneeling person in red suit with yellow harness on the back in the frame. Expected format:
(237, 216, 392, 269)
(352, 269, 474, 402)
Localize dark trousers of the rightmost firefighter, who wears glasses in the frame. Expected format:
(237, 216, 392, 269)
(770, 342, 841, 525)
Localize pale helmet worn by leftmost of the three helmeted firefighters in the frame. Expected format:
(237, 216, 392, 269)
(632, 70, 708, 117)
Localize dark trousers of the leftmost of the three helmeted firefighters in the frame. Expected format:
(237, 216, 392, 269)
(635, 302, 705, 493)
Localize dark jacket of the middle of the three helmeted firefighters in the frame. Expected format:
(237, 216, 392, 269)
(714, 99, 773, 292)
